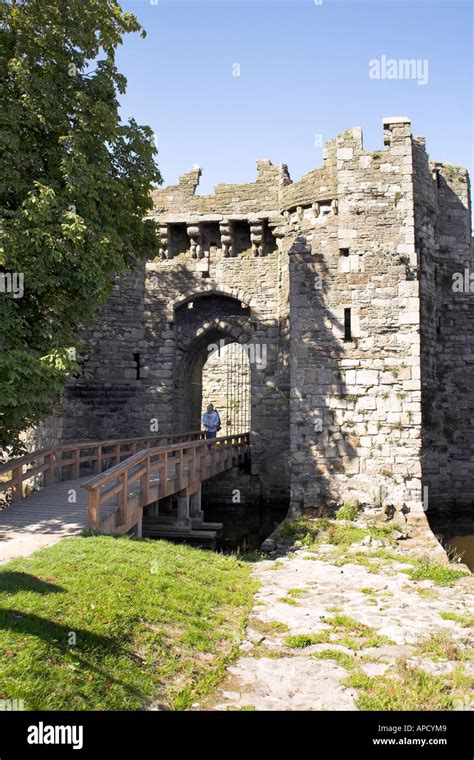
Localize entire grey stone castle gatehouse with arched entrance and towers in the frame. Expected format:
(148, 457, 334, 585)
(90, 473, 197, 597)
(39, 117, 474, 514)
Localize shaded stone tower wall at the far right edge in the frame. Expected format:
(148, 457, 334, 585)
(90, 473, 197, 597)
(415, 150, 474, 510)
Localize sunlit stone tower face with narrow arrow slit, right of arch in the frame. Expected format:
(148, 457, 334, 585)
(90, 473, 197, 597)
(288, 119, 421, 512)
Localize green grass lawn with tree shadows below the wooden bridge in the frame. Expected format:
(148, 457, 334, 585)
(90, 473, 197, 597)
(0, 536, 256, 710)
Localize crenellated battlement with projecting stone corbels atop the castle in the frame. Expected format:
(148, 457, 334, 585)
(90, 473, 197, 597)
(151, 116, 468, 263)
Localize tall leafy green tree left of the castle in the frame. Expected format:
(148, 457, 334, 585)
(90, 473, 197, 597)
(0, 0, 161, 455)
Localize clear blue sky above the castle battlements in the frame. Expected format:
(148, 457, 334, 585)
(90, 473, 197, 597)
(118, 0, 473, 209)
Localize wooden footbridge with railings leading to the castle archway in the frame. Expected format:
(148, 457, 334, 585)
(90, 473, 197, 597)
(0, 431, 249, 543)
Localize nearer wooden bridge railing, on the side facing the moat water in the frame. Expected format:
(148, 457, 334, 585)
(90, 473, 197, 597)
(81, 433, 250, 529)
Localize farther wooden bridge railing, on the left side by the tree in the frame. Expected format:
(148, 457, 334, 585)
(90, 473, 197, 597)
(0, 430, 205, 501)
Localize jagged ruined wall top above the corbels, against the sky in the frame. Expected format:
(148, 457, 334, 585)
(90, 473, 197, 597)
(151, 116, 468, 224)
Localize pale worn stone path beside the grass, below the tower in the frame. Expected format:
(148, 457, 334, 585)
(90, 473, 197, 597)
(206, 524, 474, 710)
